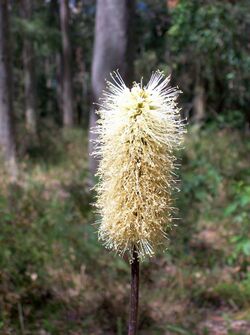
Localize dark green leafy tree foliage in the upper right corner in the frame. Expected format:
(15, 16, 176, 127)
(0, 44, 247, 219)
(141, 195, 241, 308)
(168, 0, 250, 112)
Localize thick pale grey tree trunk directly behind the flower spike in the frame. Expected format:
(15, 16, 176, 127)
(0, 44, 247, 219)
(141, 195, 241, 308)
(89, 0, 135, 174)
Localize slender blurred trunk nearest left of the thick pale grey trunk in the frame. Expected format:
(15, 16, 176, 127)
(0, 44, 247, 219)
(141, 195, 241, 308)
(60, 0, 74, 127)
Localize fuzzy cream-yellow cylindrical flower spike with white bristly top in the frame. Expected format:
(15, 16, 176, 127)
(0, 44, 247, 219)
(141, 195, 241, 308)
(95, 71, 184, 260)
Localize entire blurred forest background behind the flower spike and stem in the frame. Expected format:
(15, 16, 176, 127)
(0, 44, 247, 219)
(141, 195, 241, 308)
(0, 0, 250, 335)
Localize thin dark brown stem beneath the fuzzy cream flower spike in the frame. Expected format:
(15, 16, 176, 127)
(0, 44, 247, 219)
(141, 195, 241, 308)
(128, 247, 139, 335)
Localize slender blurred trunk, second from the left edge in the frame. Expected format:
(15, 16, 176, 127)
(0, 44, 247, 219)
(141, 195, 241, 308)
(22, 0, 37, 135)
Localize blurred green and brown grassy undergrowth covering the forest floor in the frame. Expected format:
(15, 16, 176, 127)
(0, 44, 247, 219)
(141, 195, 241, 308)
(0, 124, 250, 335)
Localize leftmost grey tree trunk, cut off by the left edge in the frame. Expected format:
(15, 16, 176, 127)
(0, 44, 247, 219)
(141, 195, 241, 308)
(0, 0, 17, 178)
